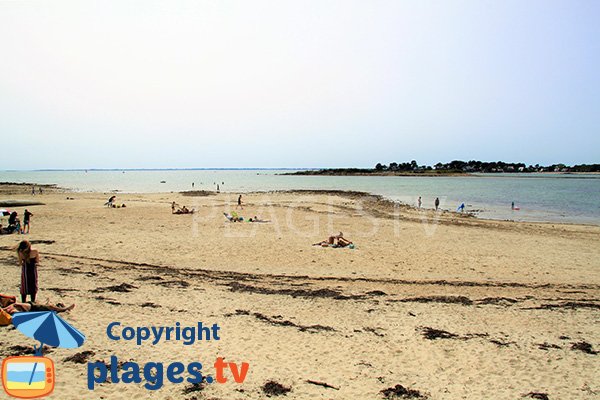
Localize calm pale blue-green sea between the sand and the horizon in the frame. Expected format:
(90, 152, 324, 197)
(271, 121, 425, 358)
(0, 170, 600, 225)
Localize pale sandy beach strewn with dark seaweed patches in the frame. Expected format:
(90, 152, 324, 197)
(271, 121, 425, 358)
(0, 185, 600, 400)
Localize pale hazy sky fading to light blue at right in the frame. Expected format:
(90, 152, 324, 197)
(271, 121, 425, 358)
(0, 0, 600, 170)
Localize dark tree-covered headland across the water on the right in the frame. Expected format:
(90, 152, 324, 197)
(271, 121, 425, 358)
(288, 160, 600, 175)
